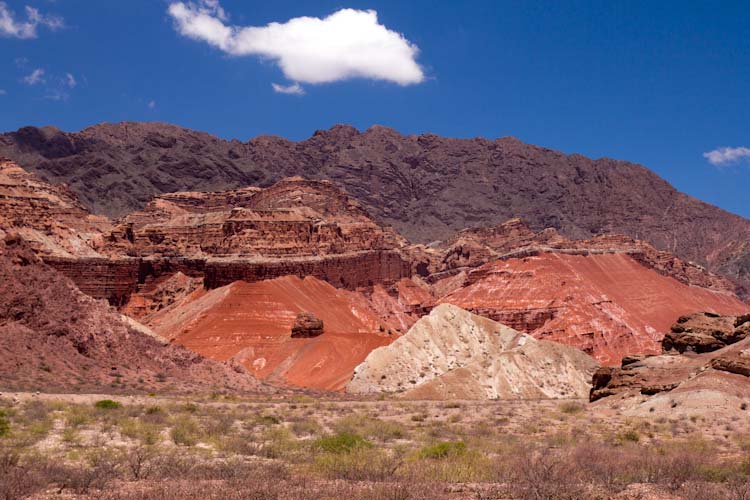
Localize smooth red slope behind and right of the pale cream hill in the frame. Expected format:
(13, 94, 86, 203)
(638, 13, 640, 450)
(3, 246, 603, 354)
(439, 252, 748, 365)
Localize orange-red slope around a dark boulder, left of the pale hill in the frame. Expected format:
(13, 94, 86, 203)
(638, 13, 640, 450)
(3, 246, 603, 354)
(142, 276, 395, 390)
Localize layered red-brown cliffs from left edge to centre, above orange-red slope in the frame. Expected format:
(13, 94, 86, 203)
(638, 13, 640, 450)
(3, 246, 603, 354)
(0, 161, 411, 305)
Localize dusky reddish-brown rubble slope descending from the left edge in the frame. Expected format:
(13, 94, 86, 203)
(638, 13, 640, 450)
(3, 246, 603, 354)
(0, 236, 269, 393)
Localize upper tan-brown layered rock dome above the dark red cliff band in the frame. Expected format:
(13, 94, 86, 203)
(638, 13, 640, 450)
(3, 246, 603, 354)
(108, 178, 405, 258)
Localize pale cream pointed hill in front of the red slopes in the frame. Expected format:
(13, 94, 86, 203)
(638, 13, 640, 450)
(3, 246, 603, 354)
(347, 304, 597, 399)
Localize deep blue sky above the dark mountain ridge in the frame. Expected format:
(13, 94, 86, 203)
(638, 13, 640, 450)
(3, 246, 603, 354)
(0, 0, 750, 216)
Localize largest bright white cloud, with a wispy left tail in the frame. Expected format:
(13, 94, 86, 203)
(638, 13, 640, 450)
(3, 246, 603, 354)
(168, 0, 425, 86)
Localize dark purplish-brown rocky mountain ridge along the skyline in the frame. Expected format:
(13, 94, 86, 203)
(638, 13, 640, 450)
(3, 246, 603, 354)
(0, 122, 750, 294)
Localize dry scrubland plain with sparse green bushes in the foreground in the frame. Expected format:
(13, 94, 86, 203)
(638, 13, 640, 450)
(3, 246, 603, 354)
(0, 396, 750, 500)
